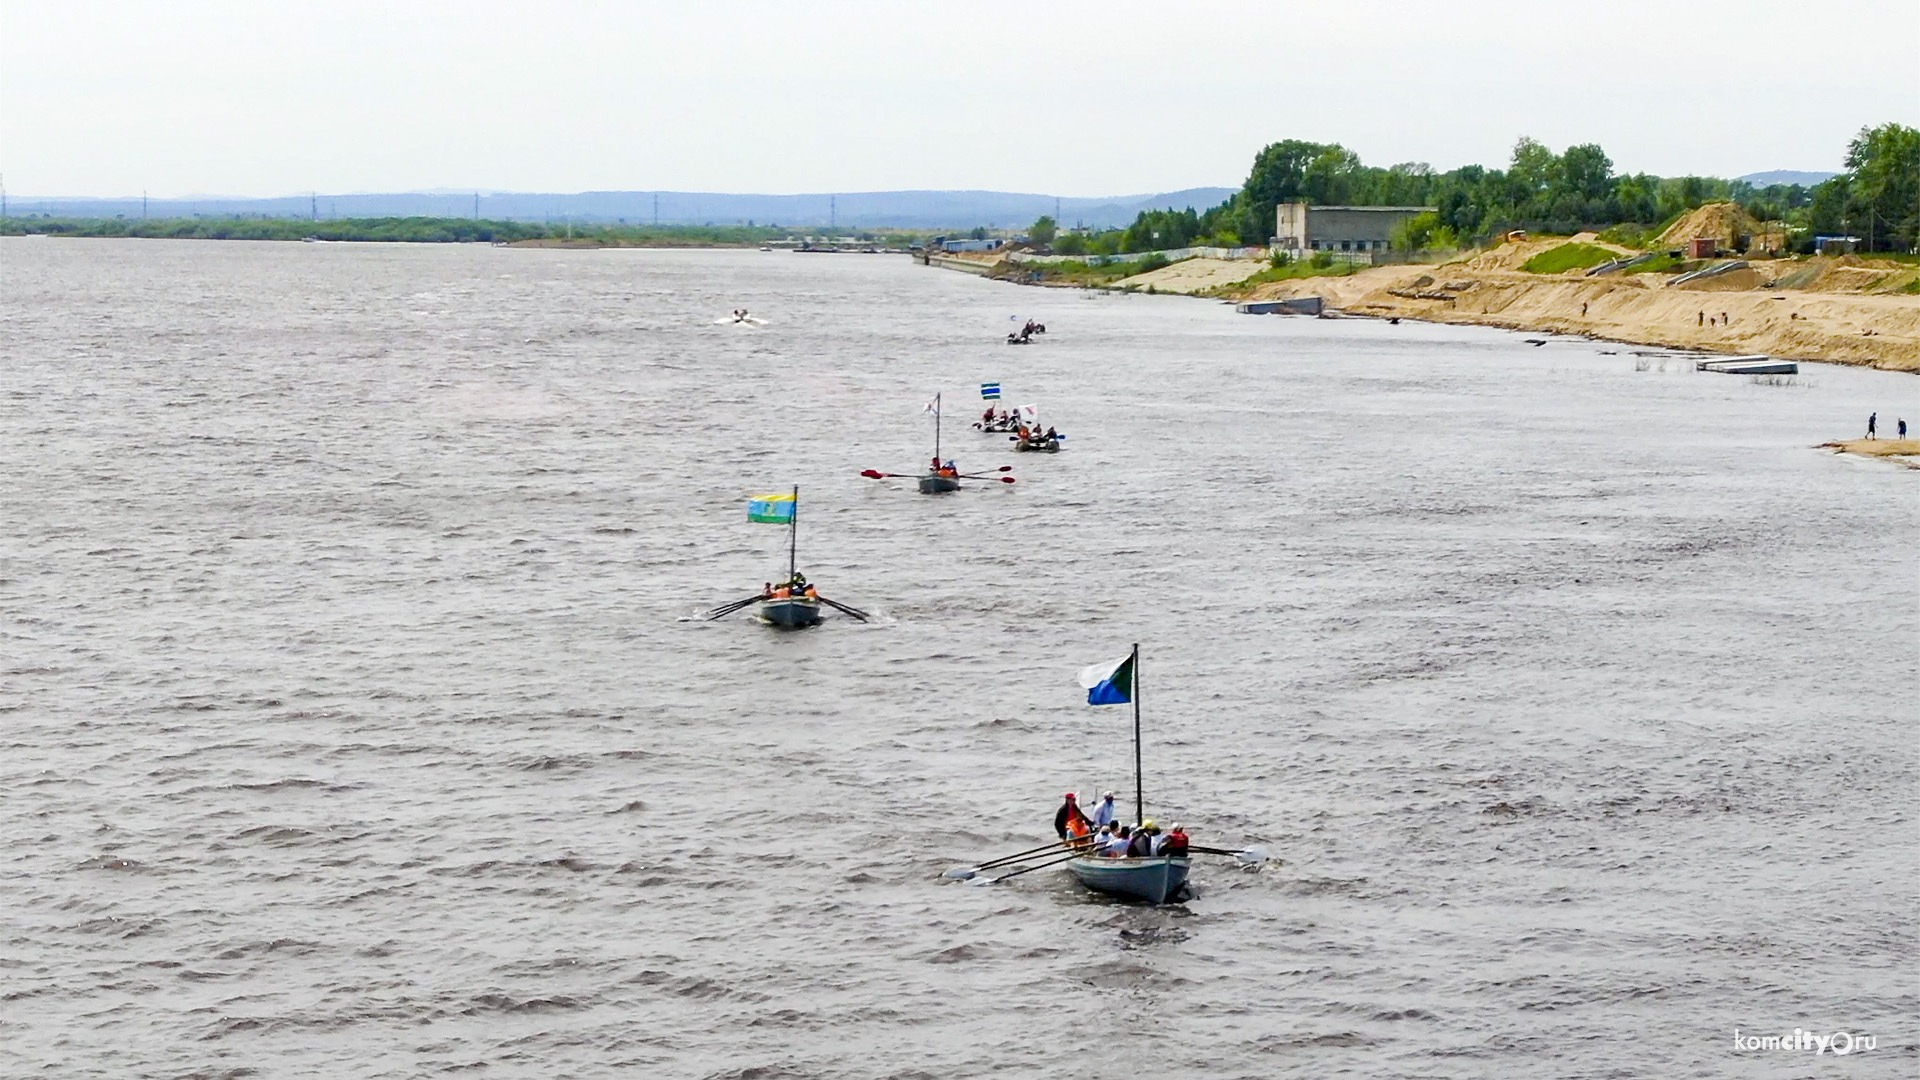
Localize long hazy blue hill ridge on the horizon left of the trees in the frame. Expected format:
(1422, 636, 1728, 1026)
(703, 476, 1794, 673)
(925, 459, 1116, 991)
(8, 188, 1235, 229)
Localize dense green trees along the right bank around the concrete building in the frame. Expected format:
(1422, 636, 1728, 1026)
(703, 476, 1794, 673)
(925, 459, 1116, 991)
(1035, 123, 1920, 256)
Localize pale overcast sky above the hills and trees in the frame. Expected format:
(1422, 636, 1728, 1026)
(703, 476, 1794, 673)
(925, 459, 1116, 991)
(0, 0, 1920, 196)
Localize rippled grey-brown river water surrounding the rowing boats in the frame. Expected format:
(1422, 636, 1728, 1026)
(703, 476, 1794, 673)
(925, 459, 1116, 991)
(0, 238, 1920, 1078)
